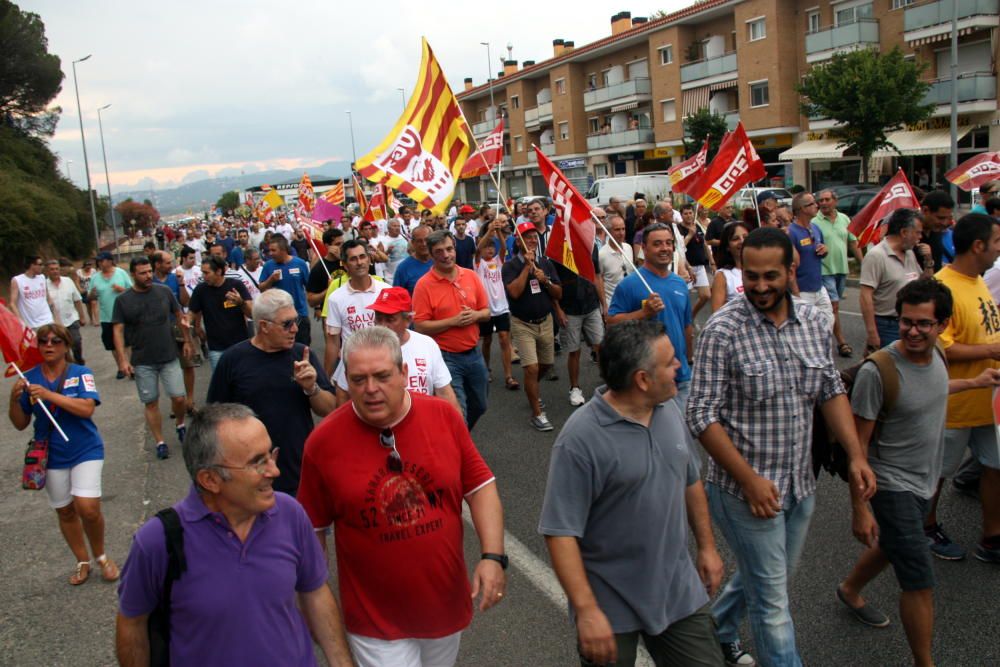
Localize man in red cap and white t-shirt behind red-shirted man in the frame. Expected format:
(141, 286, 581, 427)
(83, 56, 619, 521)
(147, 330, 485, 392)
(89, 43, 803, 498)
(333, 287, 461, 412)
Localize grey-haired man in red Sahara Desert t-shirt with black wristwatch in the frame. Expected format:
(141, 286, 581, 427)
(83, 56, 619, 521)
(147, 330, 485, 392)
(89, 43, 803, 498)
(298, 326, 507, 667)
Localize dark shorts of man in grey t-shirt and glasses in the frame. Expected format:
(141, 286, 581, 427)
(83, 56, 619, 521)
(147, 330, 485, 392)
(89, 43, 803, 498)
(871, 491, 934, 591)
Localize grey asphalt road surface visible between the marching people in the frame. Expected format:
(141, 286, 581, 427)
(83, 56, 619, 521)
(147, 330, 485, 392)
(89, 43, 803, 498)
(0, 289, 1000, 667)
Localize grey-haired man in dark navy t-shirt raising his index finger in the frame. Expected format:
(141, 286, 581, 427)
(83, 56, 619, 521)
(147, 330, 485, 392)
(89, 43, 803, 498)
(208, 289, 337, 495)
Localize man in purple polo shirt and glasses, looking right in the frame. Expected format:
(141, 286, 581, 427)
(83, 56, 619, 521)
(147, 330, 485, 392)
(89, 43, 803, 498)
(116, 403, 354, 667)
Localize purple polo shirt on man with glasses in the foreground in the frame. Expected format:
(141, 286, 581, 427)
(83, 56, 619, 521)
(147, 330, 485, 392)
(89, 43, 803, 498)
(118, 487, 327, 667)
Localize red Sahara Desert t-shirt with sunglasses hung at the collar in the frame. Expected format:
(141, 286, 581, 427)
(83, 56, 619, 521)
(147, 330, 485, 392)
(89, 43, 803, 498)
(299, 393, 494, 640)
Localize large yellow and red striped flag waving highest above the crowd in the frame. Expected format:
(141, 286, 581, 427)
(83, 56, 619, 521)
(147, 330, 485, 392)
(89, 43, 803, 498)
(355, 39, 471, 213)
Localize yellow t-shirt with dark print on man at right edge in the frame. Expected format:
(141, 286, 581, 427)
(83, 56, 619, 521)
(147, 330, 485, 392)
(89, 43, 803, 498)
(934, 265, 1000, 428)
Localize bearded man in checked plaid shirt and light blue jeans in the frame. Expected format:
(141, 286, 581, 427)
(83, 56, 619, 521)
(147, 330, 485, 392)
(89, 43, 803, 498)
(687, 228, 875, 666)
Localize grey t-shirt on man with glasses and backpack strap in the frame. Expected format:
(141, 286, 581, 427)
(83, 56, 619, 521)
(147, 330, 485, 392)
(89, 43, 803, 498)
(851, 345, 948, 498)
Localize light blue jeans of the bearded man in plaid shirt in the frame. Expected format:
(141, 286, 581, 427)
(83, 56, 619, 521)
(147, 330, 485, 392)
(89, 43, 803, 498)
(705, 483, 815, 667)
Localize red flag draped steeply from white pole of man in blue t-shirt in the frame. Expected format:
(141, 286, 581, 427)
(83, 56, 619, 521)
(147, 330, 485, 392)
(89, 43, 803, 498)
(534, 146, 594, 282)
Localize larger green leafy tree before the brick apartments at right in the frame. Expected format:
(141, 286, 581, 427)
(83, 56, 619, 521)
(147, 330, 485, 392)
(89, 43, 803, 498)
(797, 47, 934, 183)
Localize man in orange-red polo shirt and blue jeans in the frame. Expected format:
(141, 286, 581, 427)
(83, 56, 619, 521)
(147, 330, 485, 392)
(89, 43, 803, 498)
(413, 229, 490, 431)
